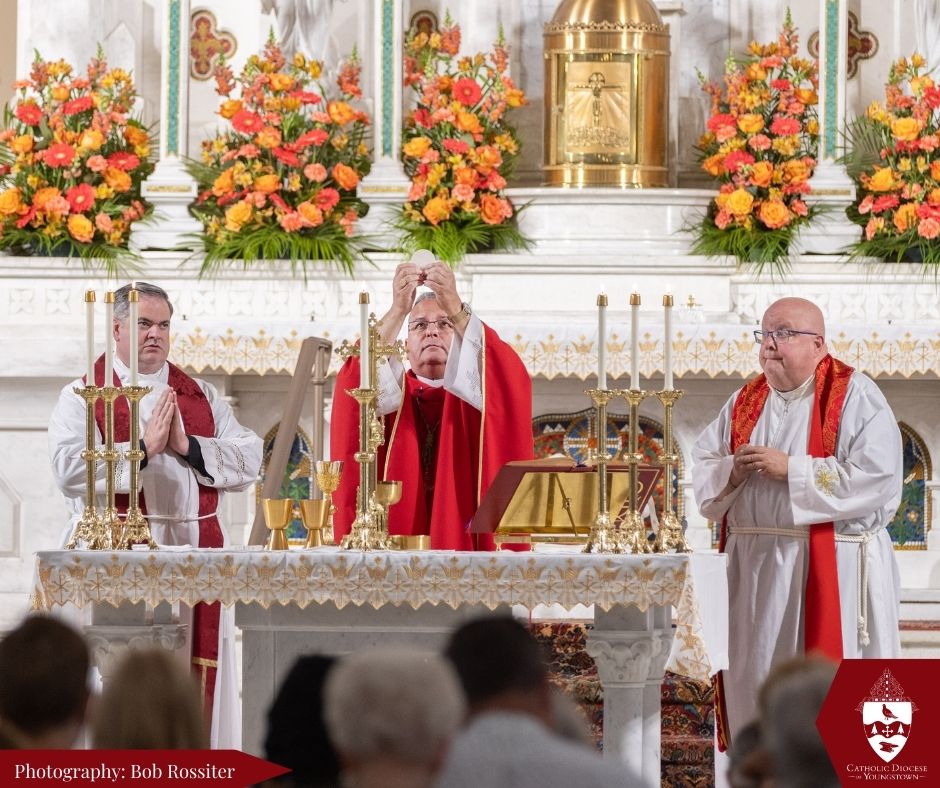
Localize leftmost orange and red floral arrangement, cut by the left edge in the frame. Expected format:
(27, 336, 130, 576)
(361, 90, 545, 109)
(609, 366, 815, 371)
(0, 48, 153, 271)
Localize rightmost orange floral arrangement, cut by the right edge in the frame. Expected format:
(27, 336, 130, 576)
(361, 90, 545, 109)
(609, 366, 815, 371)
(846, 53, 940, 270)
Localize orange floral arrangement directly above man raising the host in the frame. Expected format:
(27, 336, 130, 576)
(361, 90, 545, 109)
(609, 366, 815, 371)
(396, 14, 528, 265)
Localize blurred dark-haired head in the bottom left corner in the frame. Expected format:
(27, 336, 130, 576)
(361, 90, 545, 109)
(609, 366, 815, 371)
(0, 616, 91, 749)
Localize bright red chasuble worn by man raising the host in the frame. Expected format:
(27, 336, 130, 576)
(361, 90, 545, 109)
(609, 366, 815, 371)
(330, 325, 533, 550)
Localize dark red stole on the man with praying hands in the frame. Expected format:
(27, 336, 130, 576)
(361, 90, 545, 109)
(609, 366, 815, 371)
(95, 355, 223, 719)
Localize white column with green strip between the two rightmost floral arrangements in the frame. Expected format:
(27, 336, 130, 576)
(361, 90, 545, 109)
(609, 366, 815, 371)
(799, 0, 859, 254)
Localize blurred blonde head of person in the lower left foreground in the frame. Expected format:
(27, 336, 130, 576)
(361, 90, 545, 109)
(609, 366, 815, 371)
(92, 648, 209, 750)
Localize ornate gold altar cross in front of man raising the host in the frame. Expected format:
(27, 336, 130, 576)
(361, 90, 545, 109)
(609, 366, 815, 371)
(338, 304, 403, 550)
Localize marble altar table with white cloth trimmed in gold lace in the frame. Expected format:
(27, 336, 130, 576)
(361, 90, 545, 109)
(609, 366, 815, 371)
(38, 548, 727, 784)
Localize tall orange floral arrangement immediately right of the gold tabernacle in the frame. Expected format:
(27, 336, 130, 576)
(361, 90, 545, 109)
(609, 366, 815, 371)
(693, 12, 819, 271)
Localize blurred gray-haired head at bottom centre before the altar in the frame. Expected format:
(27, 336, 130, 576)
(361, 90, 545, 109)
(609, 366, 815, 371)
(324, 648, 466, 763)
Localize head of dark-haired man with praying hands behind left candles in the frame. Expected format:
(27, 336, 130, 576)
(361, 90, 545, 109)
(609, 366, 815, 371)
(114, 282, 173, 375)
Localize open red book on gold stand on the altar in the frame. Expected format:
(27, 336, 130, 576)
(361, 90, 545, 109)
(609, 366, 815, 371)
(470, 458, 662, 542)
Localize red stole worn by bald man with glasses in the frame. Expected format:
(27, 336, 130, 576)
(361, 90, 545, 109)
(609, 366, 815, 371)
(716, 355, 854, 750)
